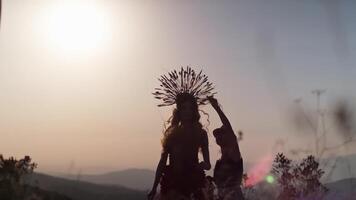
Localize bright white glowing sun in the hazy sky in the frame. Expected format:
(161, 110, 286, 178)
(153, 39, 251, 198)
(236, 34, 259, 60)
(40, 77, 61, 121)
(44, 2, 110, 54)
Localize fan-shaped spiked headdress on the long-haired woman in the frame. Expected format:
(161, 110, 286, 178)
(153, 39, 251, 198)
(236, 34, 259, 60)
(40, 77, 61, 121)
(152, 67, 216, 107)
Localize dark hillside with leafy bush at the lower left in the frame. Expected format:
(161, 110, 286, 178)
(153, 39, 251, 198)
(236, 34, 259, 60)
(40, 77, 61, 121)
(0, 156, 146, 200)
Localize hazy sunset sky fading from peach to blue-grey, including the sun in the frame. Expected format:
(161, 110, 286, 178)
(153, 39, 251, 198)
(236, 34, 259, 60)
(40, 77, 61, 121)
(0, 0, 356, 173)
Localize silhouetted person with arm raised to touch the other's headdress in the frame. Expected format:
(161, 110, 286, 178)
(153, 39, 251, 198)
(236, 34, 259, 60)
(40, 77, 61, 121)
(208, 96, 244, 200)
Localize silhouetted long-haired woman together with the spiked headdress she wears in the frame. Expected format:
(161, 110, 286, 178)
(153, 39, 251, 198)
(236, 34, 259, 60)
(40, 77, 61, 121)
(148, 68, 211, 200)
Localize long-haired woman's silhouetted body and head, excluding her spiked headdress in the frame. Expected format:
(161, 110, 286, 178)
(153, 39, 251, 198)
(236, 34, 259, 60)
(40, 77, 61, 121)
(149, 94, 211, 199)
